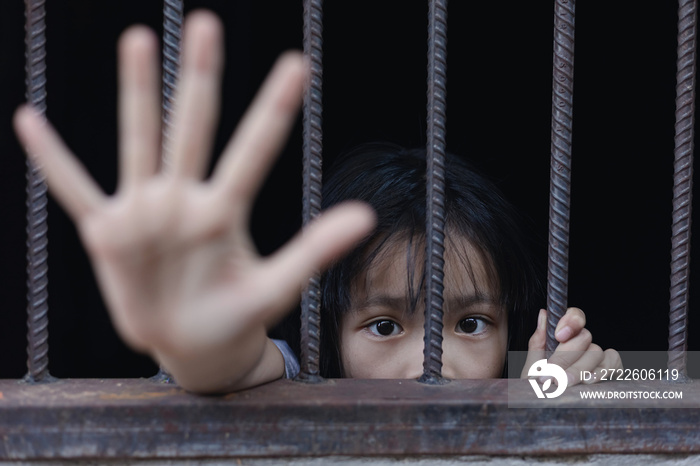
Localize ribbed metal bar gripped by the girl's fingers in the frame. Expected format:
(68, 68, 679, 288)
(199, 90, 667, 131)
(546, 0, 576, 354)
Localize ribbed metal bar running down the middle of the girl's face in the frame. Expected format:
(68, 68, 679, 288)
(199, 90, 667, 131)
(419, 0, 447, 384)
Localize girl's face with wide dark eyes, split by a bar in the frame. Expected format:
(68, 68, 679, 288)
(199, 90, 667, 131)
(340, 236, 508, 379)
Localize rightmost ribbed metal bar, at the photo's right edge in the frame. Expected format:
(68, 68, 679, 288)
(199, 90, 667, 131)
(668, 0, 697, 380)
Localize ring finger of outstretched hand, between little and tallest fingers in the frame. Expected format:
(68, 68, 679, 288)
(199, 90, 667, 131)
(119, 27, 161, 188)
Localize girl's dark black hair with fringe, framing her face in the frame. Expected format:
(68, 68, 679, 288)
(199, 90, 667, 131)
(320, 143, 540, 377)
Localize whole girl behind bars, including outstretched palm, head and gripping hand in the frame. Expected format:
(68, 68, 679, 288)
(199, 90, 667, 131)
(15, 12, 620, 392)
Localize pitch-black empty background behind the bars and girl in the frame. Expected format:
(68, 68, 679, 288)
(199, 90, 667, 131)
(0, 0, 700, 378)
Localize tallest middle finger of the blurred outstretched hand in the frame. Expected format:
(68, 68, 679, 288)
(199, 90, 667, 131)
(166, 11, 224, 178)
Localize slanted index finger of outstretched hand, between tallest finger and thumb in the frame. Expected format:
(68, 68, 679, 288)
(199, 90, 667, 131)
(214, 52, 306, 203)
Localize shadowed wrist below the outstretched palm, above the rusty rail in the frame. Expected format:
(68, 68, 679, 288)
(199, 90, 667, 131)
(153, 330, 284, 394)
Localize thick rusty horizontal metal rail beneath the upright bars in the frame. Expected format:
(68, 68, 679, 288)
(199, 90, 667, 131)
(0, 379, 700, 463)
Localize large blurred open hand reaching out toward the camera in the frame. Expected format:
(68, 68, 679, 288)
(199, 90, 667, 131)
(15, 12, 373, 392)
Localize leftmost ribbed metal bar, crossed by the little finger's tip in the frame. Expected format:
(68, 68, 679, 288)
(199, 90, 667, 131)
(25, 0, 52, 383)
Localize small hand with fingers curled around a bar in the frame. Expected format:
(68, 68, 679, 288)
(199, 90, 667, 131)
(521, 307, 622, 386)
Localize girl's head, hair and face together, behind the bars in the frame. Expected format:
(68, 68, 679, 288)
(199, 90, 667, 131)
(321, 144, 540, 378)
